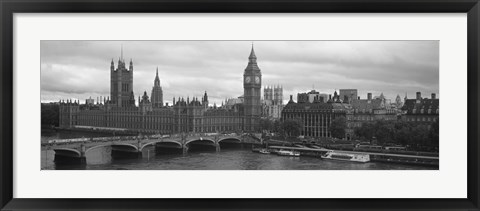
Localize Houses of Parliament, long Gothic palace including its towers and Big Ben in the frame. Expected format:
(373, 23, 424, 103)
(59, 45, 262, 134)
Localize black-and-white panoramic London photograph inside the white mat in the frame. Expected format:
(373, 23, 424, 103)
(40, 40, 438, 171)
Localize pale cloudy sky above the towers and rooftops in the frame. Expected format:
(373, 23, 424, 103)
(41, 41, 440, 104)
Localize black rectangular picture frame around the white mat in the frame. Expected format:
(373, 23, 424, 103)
(0, 0, 480, 210)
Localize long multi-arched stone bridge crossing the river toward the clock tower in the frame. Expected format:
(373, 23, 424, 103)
(41, 133, 263, 163)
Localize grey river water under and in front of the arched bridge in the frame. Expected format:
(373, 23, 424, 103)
(41, 133, 438, 170)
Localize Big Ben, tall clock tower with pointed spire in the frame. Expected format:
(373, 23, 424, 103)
(243, 44, 262, 132)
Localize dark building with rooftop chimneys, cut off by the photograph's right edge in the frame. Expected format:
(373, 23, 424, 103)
(402, 92, 439, 127)
